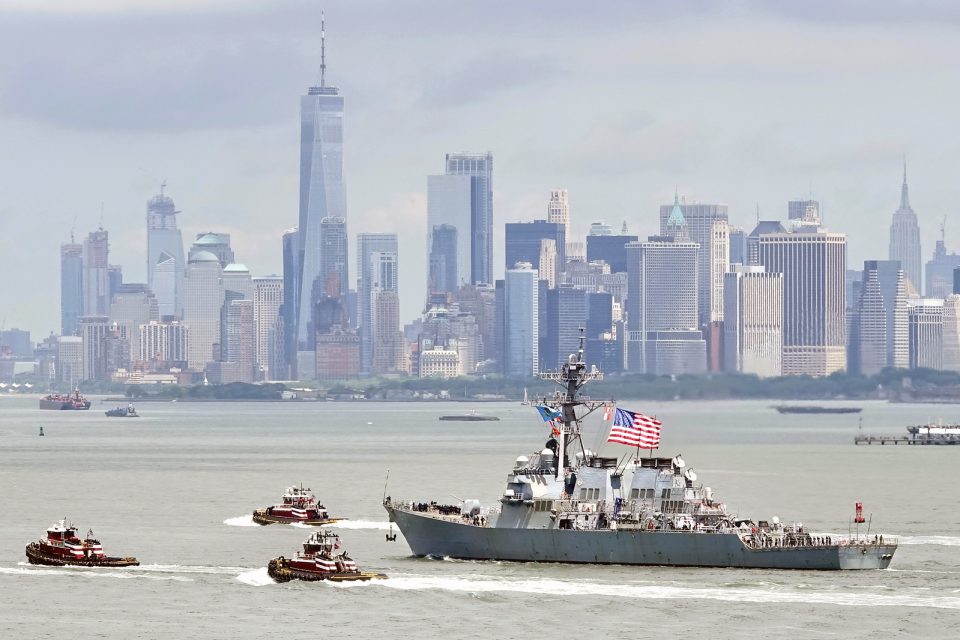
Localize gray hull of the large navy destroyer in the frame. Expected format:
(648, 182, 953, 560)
(385, 504, 896, 570)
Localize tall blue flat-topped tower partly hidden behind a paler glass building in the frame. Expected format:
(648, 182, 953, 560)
(446, 153, 493, 284)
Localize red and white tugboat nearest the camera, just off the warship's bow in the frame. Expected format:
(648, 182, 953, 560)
(267, 529, 387, 582)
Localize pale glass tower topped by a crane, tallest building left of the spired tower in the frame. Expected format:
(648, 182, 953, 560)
(147, 183, 185, 316)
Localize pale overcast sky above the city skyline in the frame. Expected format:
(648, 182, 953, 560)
(0, 0, 960, 340)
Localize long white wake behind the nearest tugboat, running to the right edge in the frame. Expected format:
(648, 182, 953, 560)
(338, 575, 960, 610)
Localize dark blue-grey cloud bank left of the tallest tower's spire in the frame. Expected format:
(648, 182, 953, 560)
(0, 38, 308, 131)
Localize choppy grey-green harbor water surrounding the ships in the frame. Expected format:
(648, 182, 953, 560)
(0, 398, 960, 638)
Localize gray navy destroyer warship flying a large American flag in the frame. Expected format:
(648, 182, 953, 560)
(383, 337, 897, 570)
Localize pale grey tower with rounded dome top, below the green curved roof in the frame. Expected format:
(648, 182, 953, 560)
(183, 251, 224, 371)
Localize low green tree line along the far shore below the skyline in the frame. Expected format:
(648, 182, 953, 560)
(99, 369, 960, 401)
